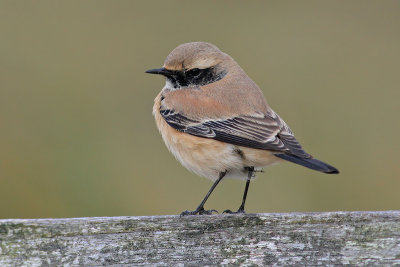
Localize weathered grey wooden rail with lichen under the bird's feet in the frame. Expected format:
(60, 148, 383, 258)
(0, 211, 400, 266)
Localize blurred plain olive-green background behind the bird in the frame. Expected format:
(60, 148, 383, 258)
(0, 1, 400, 218)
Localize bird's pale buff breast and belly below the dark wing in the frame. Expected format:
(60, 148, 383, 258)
(153, 93, 281, 180)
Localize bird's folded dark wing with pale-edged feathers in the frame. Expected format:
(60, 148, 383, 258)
(160, 108, 311, 158)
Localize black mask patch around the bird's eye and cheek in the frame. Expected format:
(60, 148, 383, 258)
(167, 67, 226, 88)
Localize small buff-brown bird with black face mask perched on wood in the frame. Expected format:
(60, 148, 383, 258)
(146, 42, 339, 216)
